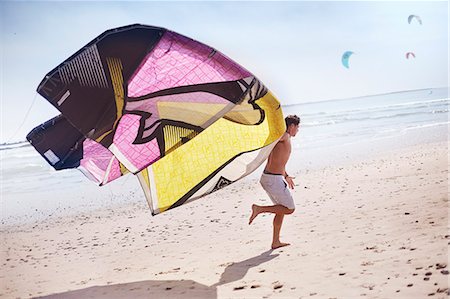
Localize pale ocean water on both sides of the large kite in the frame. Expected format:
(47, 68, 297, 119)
(0, 88, 450, 224)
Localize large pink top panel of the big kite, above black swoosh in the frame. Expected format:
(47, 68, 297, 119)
(128, 31, 251, 97)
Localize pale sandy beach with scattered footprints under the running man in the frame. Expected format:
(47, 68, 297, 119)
(0, 142, 450, 298)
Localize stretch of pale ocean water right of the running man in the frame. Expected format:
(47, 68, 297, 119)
(283, 88, 450, 168)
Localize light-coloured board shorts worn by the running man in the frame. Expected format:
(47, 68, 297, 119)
(259, 173, 295, 210)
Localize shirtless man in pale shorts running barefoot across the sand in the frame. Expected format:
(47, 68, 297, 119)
(248, 115, 300, 249)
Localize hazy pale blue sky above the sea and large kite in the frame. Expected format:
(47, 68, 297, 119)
(0, 1, 449, 142)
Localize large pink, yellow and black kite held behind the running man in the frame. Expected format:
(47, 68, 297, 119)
(27, 24, 286, 215)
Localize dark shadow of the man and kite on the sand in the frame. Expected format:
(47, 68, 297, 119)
(38, 250, 278, 299)
